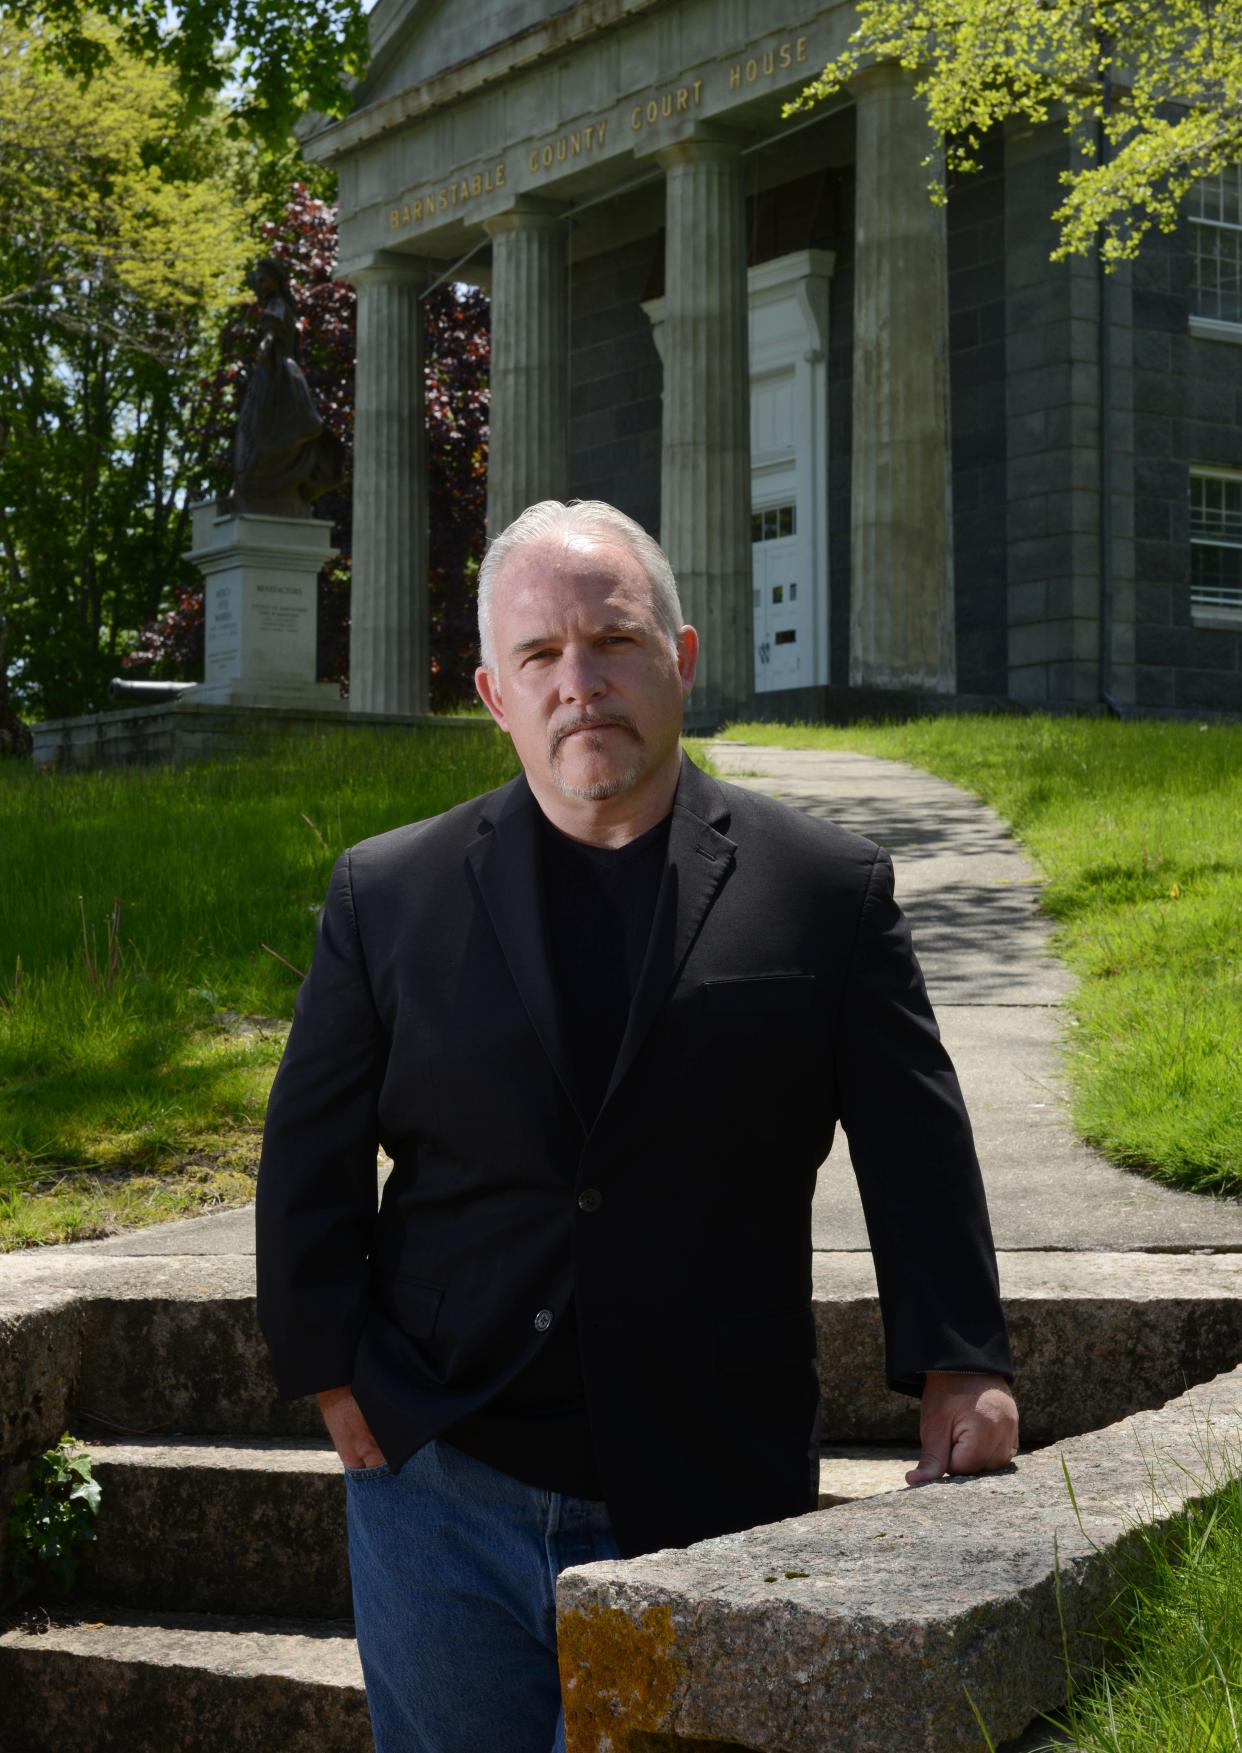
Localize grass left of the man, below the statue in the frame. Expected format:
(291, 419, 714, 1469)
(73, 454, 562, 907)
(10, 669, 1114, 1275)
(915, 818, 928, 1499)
(0, 724, 516, 1248)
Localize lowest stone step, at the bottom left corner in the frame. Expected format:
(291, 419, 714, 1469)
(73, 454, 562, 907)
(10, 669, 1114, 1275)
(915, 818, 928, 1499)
(0, 1606, 374, 1753)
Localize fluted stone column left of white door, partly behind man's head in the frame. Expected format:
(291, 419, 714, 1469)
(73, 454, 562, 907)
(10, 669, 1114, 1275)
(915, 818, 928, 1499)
(656, 138, 754, 724)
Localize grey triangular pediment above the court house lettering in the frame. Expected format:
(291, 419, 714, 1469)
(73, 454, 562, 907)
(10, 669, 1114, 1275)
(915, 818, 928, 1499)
(354, 0, 575, 109)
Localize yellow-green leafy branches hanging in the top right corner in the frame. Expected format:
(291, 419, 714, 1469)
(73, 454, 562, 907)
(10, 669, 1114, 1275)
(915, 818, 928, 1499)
(786, 0, 1242, 266)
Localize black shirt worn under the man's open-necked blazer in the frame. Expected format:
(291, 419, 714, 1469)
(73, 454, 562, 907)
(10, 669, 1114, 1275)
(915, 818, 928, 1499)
(444, 817, 668, 1499)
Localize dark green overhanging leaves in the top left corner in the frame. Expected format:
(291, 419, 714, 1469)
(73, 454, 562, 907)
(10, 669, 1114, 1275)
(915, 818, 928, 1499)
(5, 0, 370, 147)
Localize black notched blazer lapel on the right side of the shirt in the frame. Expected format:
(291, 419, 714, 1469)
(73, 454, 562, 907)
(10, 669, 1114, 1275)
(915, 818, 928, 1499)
(600, 756, 737, 1111)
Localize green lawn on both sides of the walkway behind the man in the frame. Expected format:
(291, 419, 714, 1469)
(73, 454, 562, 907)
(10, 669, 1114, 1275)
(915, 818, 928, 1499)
(0, 717, 1242, 1248)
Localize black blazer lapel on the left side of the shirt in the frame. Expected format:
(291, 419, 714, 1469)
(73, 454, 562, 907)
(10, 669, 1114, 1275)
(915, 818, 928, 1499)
(467, 777, 588, 1131)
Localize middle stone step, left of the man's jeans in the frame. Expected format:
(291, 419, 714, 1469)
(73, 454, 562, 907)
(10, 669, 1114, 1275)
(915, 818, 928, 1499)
(81, 1436, 353, 1620)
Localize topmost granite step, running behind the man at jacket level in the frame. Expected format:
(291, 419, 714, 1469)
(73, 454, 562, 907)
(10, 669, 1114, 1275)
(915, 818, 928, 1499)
(33, 1252, 1242, 1446)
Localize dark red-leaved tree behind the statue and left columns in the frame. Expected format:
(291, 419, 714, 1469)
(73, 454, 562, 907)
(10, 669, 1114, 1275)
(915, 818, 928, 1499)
(125, 182, 489, 708)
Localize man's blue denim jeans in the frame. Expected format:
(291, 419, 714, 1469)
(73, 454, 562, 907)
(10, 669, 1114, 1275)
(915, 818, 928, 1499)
(346, 1441, 619, 1753)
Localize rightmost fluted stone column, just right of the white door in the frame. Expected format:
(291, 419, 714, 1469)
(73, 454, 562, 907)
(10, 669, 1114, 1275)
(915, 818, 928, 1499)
(849, 65, 956, 694)
